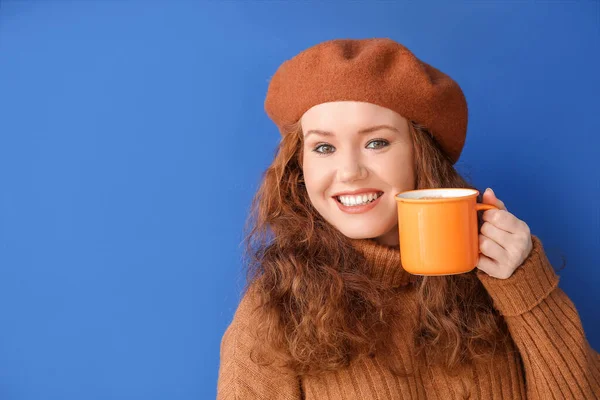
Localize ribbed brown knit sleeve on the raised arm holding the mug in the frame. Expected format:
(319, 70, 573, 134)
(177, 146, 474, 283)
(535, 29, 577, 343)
(477, 235, 600, 400)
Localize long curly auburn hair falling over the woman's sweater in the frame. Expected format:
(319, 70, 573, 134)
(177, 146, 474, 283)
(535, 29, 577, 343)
(244, 121, 510, 376)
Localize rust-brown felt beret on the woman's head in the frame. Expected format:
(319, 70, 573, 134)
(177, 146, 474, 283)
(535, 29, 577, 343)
(265, 38, 467, 163)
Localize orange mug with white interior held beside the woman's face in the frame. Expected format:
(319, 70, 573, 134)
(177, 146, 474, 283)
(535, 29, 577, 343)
(395, 188, 498, 276)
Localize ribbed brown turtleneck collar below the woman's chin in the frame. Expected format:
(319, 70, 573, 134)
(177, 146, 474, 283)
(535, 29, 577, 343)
(350, 239, 418, 287)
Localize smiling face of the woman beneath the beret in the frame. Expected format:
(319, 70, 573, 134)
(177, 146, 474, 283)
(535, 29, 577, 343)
(300, 101, 415, 246)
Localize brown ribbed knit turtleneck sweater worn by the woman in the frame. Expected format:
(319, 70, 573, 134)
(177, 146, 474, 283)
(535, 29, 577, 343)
(217, 236, 600, 400)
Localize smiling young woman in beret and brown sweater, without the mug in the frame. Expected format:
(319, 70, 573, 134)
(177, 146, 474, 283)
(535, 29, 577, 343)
(218, 39, 600, 400)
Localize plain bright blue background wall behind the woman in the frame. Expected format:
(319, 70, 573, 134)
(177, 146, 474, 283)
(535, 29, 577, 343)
(0, 1, 600, 400)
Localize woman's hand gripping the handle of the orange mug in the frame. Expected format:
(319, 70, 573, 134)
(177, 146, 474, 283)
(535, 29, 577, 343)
(477, 188, 533, 279)
